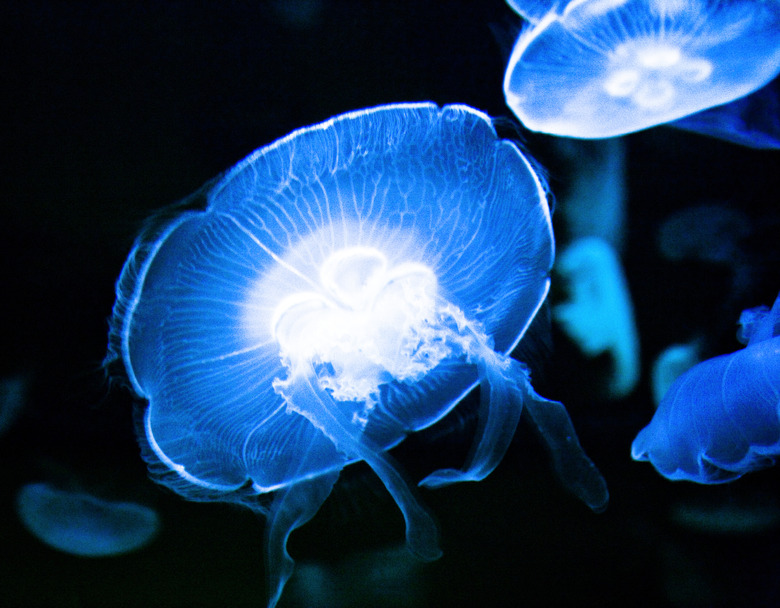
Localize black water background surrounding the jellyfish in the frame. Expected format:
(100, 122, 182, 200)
(0, 0, 780, 607)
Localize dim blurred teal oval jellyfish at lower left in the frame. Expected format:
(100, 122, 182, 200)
(16, 483, 160, 557)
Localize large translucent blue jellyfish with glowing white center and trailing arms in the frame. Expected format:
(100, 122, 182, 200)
(106, 103, 608, 606)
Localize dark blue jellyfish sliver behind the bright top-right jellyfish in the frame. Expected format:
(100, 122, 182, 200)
(669, 78, 780, 150)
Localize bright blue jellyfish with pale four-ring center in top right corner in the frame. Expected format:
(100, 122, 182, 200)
(504, 0, 780, 139)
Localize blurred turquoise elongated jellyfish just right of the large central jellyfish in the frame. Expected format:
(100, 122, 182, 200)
(553, 237, 640, 399)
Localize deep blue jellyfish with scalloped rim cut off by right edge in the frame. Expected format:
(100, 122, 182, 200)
(631, 295, 780, 483)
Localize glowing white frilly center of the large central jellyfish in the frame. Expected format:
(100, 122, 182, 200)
(271, 247, 474, 409)
